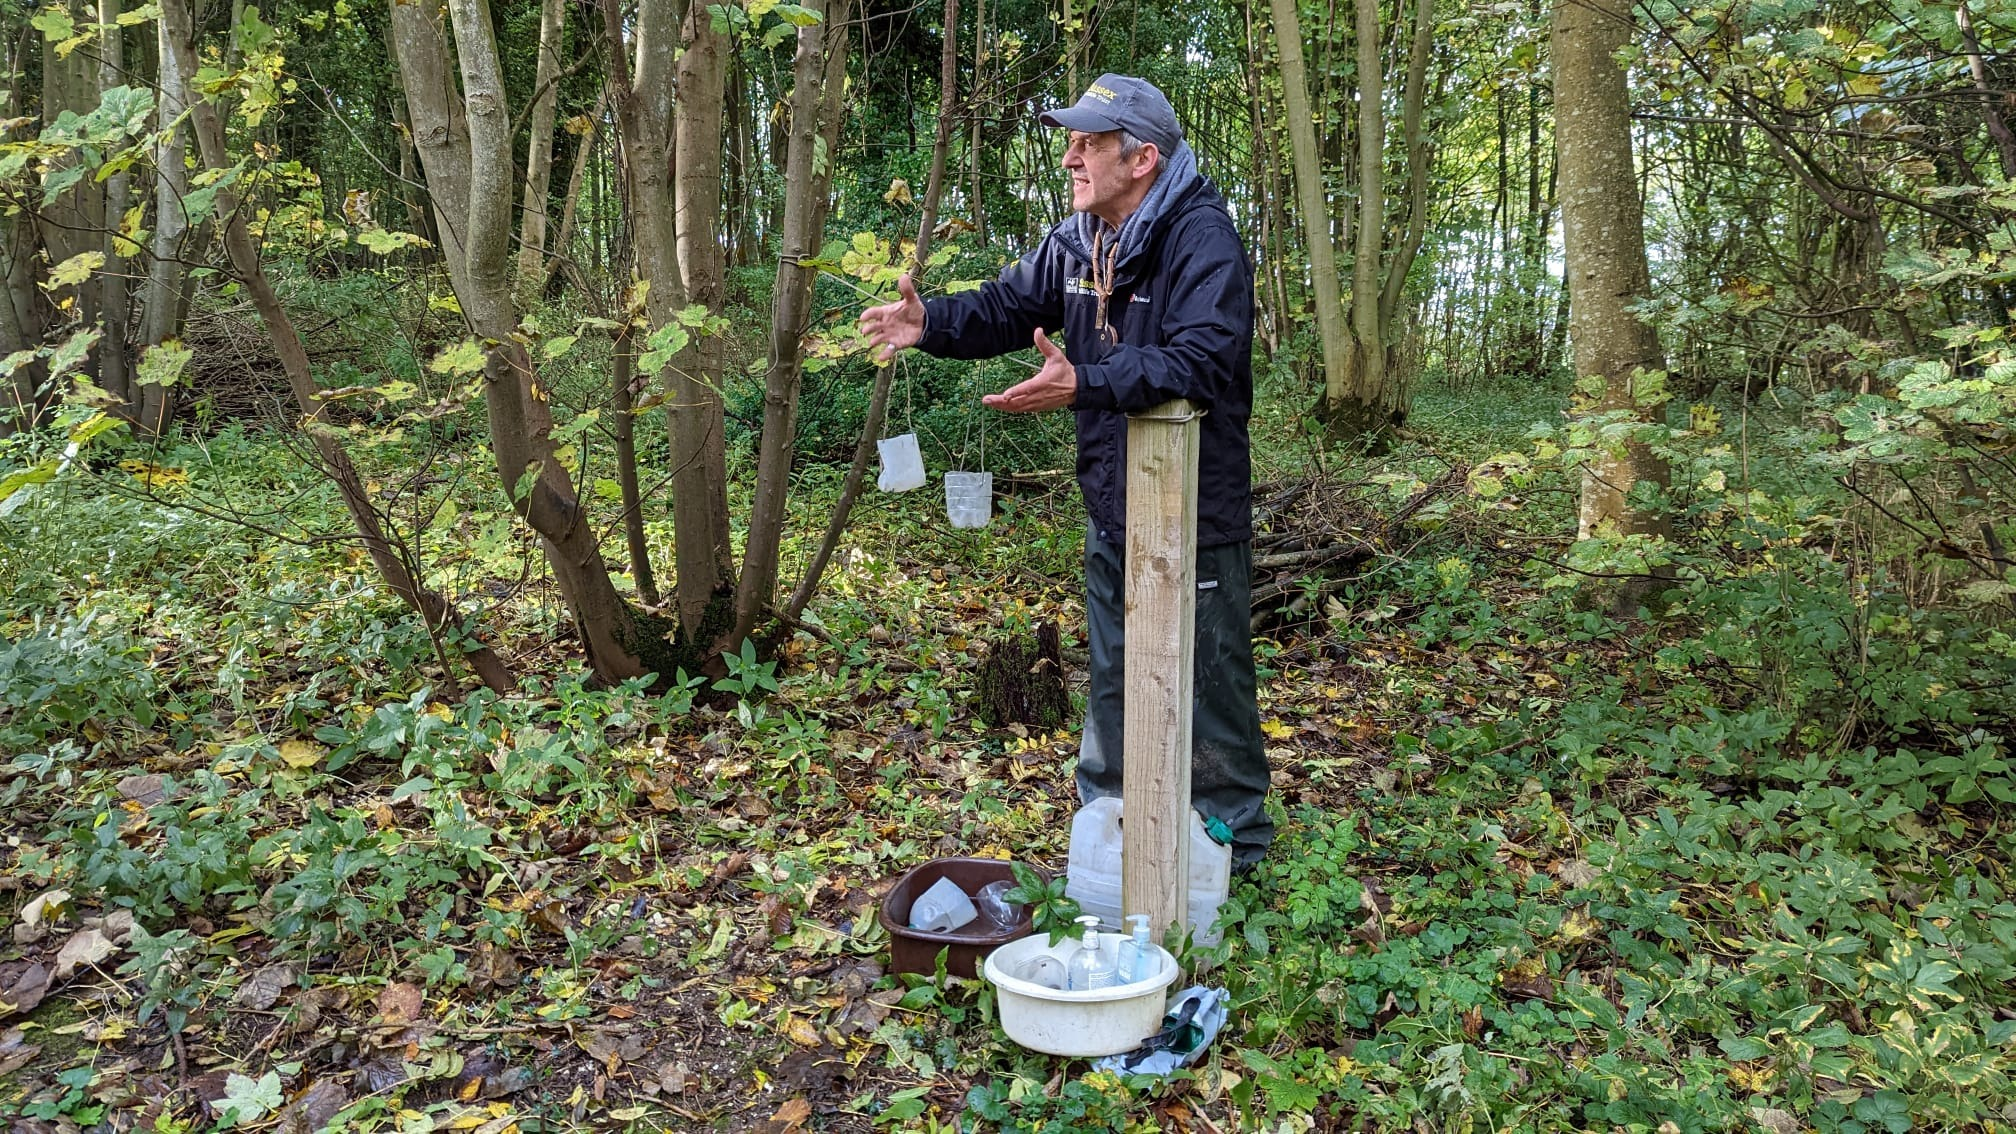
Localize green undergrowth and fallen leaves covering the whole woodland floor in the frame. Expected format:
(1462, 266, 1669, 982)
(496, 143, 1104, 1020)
(0, 373, 2016, 1134)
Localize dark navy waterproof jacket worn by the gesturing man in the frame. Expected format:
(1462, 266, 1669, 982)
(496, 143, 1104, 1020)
(917, 180, 1254, 547)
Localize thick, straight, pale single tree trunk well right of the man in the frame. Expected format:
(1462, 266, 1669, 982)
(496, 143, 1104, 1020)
(1554, 0, 1665, 539)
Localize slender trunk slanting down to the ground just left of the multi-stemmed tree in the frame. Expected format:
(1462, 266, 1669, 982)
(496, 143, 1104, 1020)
(159, 0, 514, 692)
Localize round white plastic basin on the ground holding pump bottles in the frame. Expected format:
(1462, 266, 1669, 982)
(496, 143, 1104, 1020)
(984, 934, 1181, 1059)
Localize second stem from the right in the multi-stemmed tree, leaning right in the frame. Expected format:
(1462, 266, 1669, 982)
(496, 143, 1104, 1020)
(724, 0, 849, 646)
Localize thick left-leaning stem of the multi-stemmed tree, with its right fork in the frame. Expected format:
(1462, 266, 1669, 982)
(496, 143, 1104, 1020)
(437, 0, 651, 680)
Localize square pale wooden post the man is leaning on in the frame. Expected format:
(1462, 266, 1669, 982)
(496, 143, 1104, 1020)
(1121, 400, 1200, 940)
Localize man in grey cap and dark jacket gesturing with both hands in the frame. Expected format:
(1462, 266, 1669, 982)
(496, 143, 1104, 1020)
(861, 75, 1274, 868)
